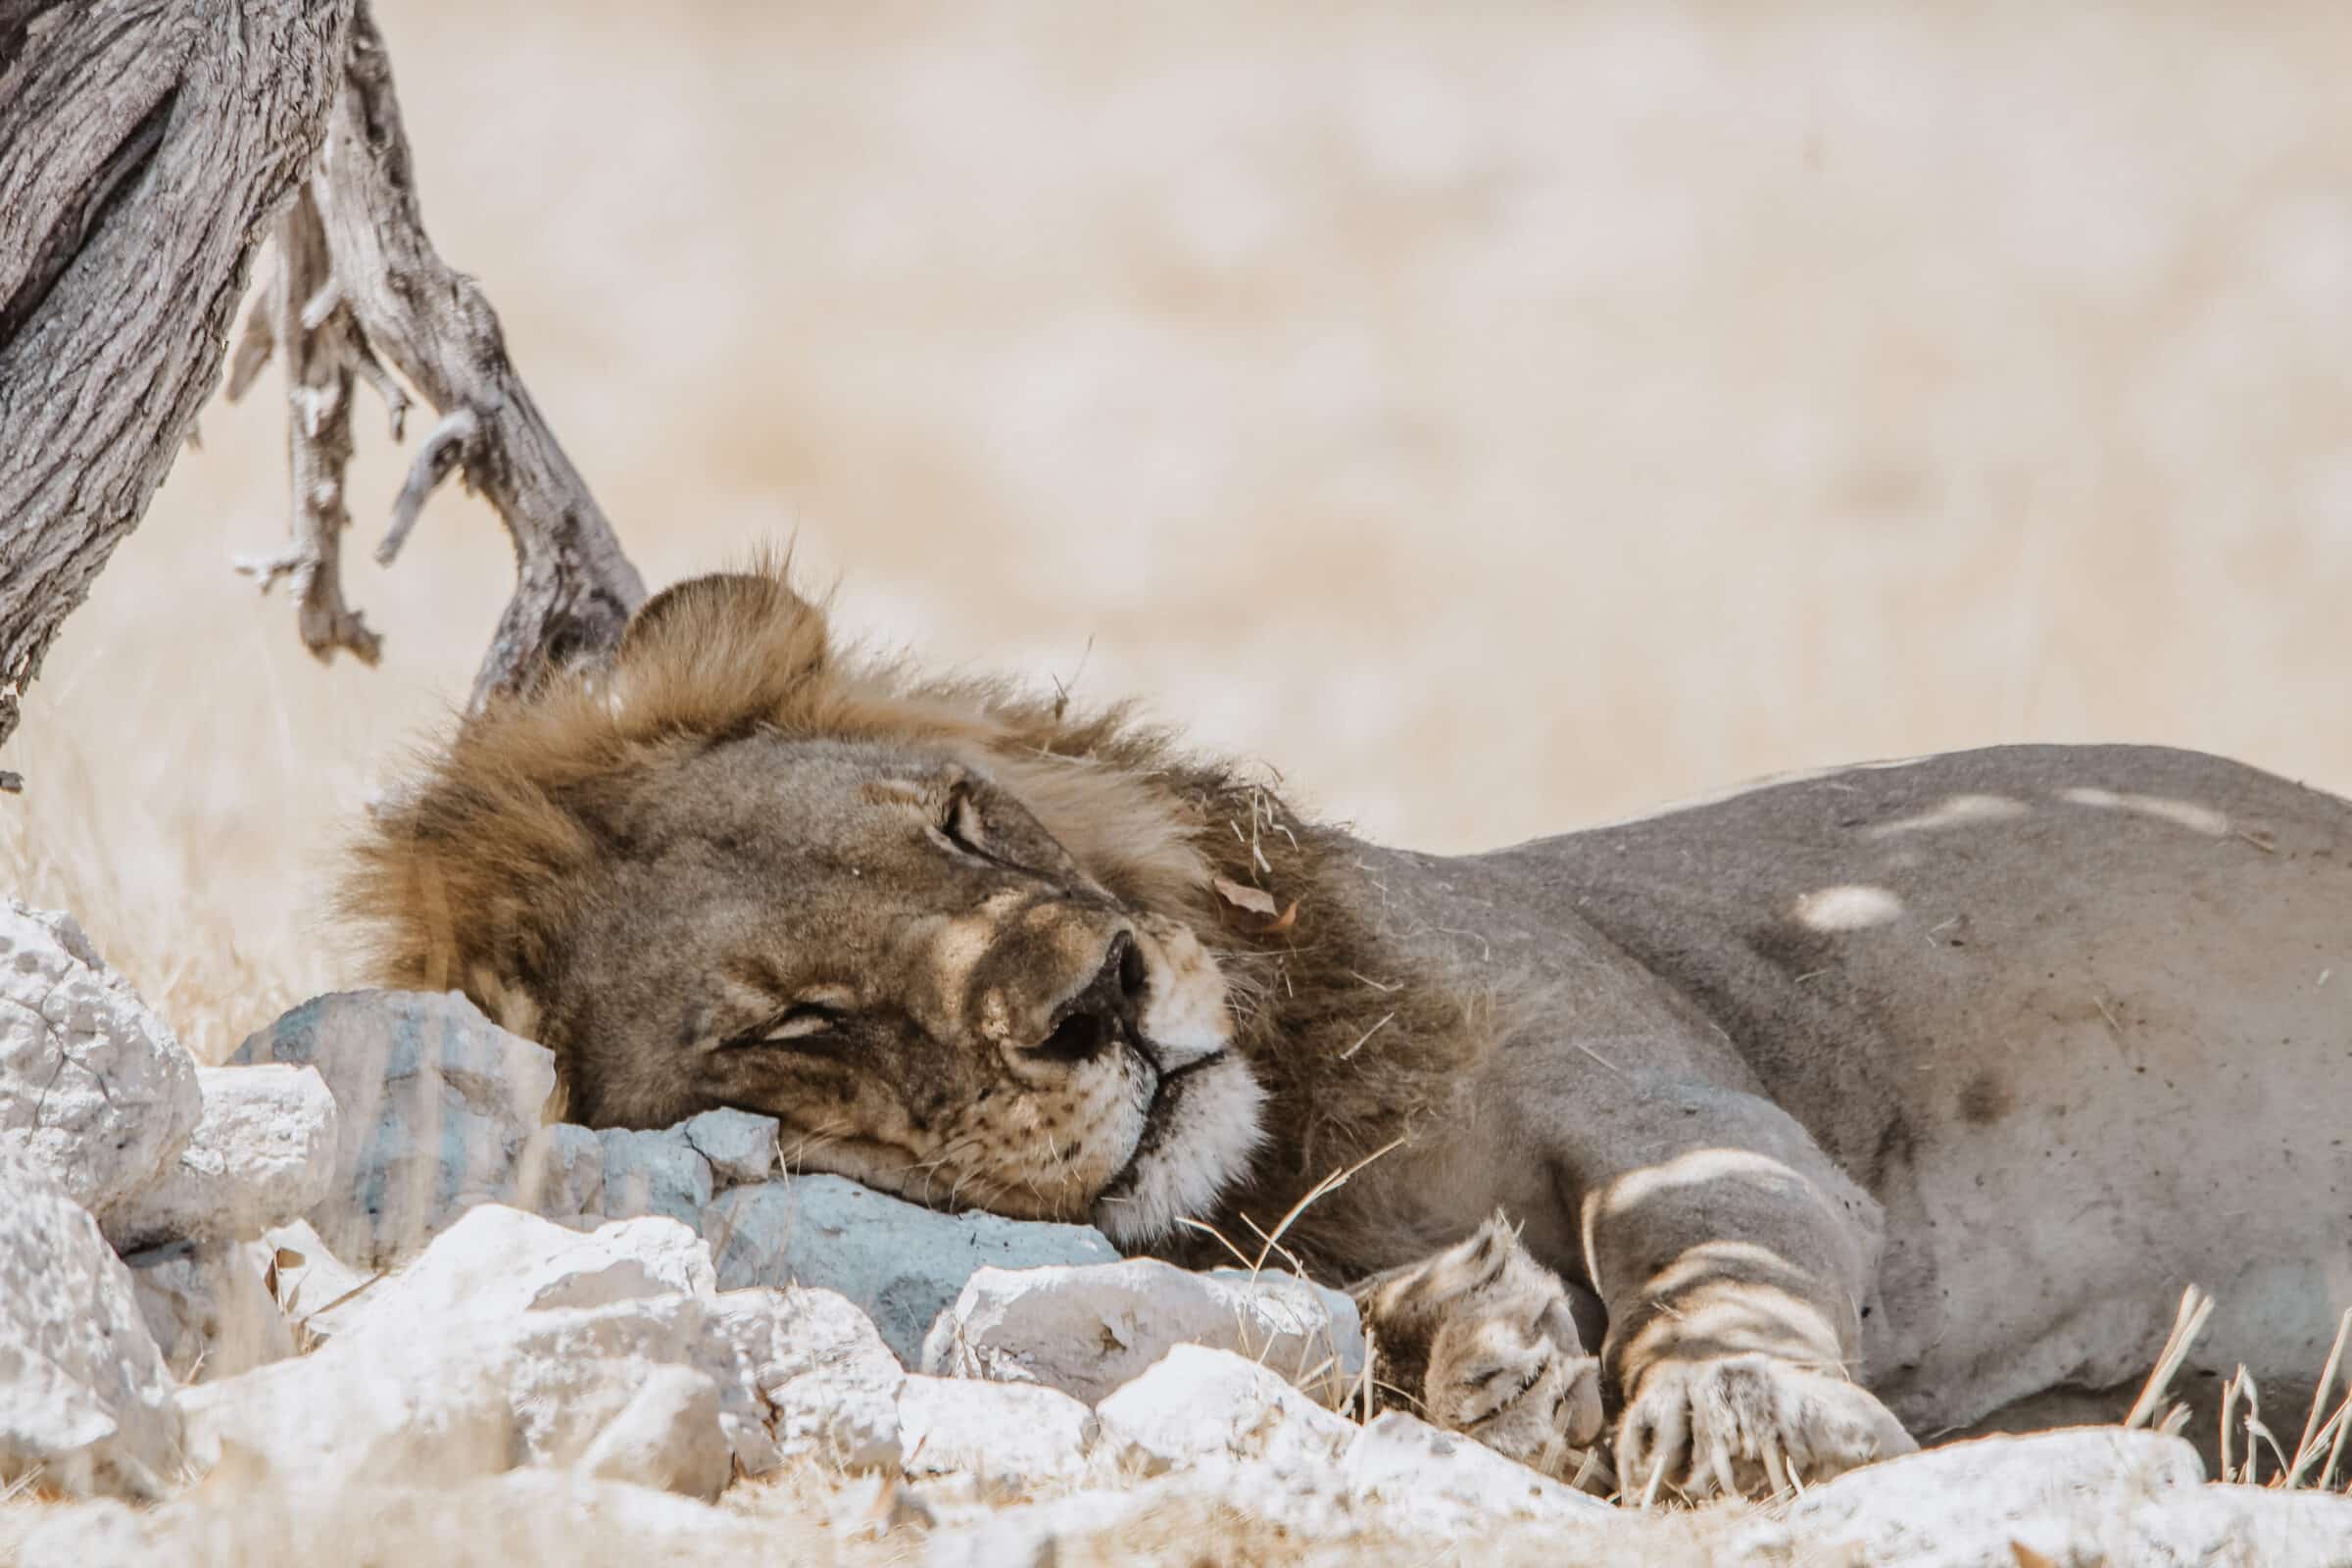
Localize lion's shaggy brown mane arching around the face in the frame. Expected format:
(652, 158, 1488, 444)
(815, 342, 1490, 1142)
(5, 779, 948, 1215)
(341, 569, 1489, 1278)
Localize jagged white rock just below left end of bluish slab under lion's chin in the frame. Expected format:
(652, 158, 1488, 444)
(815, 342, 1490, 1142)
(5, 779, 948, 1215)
(717, 1291, 906, 1474)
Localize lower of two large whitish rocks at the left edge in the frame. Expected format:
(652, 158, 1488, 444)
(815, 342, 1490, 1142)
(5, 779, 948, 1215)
(0, 1152, 193, 1497)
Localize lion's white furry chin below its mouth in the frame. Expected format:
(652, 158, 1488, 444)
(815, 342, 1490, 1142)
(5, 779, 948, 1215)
(1092, 1055, 1265, 1249)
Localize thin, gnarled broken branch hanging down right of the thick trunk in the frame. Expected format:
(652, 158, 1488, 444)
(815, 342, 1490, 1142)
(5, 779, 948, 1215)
(240, 2, 645, 708)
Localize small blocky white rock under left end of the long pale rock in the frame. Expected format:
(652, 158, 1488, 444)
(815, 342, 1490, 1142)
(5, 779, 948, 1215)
(899, 1378, 1096, 1495)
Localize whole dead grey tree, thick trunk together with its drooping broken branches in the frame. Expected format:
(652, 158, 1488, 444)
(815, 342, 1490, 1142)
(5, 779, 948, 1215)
(0, 0, 645, 785)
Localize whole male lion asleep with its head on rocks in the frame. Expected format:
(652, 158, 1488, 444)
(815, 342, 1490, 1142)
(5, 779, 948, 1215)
(348, 569, 2352, 1497)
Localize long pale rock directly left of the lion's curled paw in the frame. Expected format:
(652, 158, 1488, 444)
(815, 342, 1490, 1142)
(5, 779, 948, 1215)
(917, 1257, 1364, 1401)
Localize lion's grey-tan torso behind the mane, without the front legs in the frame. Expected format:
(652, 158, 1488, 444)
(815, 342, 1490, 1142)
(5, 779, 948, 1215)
(1298, 748, 2352, 1437)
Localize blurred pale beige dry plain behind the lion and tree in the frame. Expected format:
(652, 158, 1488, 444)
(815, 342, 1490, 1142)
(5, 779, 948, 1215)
(0, 0, 2352, 1055)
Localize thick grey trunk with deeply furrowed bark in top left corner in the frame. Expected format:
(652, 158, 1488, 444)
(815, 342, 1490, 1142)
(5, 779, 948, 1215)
(0, 0, 353, 775)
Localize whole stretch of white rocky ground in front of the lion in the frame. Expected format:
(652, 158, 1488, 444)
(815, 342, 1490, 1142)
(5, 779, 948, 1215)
(0, 903, 2352, 1568)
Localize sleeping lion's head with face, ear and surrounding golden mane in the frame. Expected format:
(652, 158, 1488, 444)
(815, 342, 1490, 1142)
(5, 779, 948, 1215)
(348, 573, 1260, 1244)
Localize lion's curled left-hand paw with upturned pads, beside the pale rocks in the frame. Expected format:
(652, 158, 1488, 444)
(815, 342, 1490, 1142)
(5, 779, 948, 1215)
(1362, 1215, 1601, 1481)
